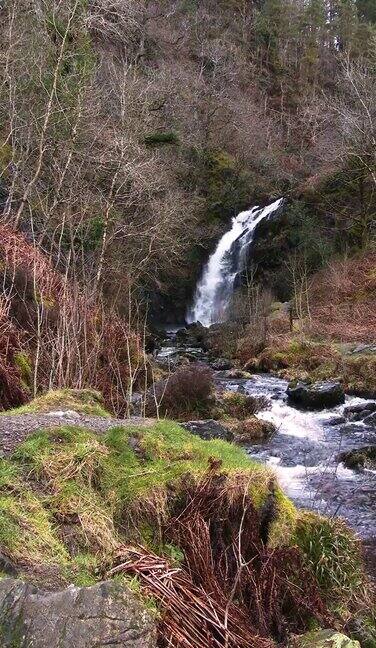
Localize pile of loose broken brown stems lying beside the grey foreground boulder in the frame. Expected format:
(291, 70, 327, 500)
(110, 547, 274, 648)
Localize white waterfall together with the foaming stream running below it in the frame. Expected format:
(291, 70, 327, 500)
(170, 194, 376, 560)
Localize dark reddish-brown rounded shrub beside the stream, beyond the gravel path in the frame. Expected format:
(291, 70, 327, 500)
(146, 364, 213, 420)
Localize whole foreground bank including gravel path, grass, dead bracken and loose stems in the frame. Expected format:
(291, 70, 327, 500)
(0, 392, 368, 648)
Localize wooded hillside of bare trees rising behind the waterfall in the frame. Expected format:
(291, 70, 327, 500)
(0, 0, 376, 319)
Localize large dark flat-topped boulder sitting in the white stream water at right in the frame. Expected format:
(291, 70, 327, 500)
(287, 381, 345, 409)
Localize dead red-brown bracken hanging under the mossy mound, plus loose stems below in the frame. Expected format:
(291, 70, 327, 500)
(110, 462, 332, 648)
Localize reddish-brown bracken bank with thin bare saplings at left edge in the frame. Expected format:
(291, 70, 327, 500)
(0, 225, 145, 415)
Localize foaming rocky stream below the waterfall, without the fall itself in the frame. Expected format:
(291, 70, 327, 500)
(159, 339, 376, 558)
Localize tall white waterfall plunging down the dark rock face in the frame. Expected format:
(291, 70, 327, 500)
(187, 198, 284, 326)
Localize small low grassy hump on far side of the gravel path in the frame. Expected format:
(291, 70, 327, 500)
(7, 389, 111, 418)
